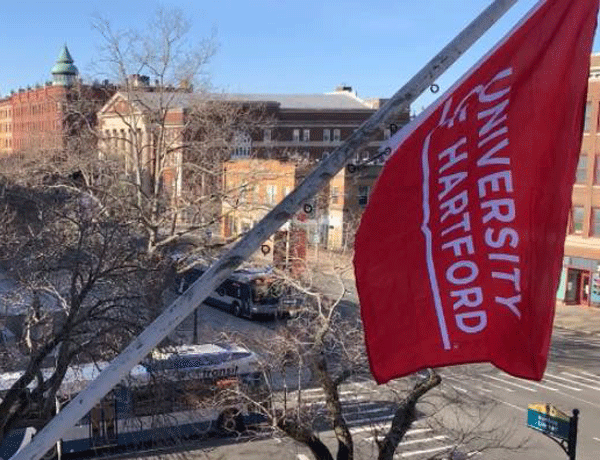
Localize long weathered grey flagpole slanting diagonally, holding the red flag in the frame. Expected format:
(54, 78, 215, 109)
(12, 0, 517, 460)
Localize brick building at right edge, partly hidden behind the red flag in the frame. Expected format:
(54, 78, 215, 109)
(557, 54, 600, 306)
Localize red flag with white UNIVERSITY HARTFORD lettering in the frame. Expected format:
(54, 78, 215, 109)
(354, 0, 598, 383)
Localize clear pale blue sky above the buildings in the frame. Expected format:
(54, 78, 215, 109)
(0, 0, 600, 111)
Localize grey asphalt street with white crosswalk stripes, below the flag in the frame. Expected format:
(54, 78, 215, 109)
(161, 277, 600, 460)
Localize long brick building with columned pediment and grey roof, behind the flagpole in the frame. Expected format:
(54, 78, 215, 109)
(98, 86, 409, 249)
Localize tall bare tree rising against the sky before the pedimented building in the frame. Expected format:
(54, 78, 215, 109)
(94, 9, 263, 253)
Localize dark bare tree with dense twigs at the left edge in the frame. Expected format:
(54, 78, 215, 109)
(0, 179, 164, 440)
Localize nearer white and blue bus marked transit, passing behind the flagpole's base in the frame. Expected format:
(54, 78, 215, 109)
(0, 344, 268, 460)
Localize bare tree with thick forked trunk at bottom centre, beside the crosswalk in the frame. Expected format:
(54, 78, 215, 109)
(216, 254, 523, 460)
